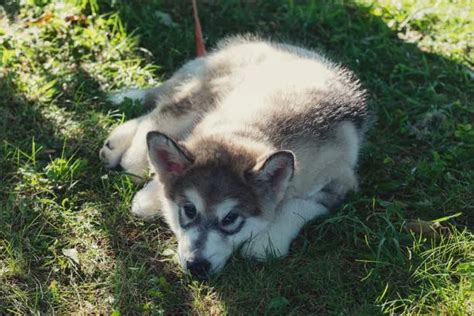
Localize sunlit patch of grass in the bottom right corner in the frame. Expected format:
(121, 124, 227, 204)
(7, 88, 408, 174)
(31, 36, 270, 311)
(383, 228, 474, 315)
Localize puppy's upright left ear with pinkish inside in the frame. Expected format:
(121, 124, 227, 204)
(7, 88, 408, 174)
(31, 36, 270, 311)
(146, 132, 193, 181)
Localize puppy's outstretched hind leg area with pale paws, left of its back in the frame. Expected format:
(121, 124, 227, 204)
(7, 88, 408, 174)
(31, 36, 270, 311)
(100, 58, 213, 181)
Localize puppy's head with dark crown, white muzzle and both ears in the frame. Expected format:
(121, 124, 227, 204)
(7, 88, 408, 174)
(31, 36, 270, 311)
(147, 132, 294, 277)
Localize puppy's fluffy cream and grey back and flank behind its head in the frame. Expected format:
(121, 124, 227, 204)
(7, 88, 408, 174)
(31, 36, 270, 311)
(186, 37, 368, 200)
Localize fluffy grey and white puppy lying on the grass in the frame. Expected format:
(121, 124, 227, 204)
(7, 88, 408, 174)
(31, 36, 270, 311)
(100, 36, 370, 278)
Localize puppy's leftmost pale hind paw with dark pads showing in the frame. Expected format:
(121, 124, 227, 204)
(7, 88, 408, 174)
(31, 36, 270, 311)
(99, 119, 138, 169)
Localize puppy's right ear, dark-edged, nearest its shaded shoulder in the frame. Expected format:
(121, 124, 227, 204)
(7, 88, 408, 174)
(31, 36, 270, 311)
(252, 150, 295, 200)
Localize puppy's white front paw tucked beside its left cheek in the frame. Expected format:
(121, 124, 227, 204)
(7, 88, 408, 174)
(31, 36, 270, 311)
(131, 180, 161, 220)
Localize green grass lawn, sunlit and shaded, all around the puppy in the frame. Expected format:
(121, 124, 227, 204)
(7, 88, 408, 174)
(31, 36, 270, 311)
(0, 0, 474, 315)
